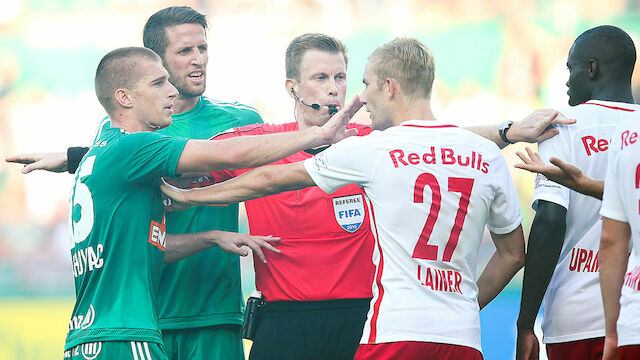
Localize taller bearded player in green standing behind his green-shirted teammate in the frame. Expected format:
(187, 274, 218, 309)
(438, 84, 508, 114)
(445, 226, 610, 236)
(8, 6, 280, 360)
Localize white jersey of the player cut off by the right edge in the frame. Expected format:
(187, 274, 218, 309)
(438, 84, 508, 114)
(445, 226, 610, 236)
(600, 114, 640, 346)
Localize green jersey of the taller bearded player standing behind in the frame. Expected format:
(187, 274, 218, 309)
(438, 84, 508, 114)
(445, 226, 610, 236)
(158, 97, 262, 330)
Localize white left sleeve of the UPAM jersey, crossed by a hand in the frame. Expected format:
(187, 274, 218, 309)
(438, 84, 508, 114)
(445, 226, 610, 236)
(532, 128, 572, 210)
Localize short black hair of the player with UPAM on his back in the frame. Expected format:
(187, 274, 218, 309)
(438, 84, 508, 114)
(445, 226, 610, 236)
(573, 25, 636, 81)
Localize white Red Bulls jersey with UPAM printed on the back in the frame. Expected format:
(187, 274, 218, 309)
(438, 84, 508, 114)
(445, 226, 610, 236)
(533, 100, 640, 343)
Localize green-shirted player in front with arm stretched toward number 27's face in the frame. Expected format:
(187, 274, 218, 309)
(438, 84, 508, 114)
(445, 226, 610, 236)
(13, 41, 361, 359)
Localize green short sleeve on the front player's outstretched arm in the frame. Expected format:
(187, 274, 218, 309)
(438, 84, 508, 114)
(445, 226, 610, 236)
(116, 132, 188, 182)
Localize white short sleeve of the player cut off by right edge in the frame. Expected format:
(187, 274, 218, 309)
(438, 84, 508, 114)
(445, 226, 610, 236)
(600, 131, 629, 222)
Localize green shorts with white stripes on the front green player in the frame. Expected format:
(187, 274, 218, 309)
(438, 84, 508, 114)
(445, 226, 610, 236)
(64, 341, 168, 360)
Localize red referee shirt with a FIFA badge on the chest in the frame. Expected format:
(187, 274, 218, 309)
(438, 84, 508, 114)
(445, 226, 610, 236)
(212, 123, 374, 301)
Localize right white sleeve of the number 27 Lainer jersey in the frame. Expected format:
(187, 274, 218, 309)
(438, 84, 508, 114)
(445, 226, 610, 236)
(487, 154, 522, 234)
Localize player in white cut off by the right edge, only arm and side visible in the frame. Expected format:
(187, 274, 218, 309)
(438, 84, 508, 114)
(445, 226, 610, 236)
(600, 116, 640, 360)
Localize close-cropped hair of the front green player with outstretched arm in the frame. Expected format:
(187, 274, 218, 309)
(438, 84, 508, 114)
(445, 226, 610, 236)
(95, 47, 162, 115)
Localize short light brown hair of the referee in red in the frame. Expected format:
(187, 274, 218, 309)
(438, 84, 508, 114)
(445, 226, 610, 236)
(285, 33, 349, 81)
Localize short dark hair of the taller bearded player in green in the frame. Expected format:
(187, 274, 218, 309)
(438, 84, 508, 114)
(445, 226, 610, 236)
(142, 6, 207, 57)
